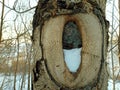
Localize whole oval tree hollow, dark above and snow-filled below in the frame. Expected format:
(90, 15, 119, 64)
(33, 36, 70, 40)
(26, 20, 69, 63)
(62, 21, 82, 74)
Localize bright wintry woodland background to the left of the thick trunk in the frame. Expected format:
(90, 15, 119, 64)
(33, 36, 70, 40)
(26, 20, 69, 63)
(0, 0, 36, 90)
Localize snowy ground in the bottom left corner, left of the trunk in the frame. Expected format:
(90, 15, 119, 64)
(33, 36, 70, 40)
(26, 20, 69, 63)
(0, 74, 31, 90)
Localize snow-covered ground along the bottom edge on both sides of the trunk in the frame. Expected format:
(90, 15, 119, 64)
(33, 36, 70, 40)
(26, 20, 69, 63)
(0, 74, 120, 90)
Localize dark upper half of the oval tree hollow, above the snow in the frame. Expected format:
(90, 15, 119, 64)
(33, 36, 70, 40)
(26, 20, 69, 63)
(62, 21, 82, 50)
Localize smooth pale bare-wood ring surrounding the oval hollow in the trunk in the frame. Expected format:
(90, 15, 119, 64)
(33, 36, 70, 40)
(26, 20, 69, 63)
(42, 13, 102, 88)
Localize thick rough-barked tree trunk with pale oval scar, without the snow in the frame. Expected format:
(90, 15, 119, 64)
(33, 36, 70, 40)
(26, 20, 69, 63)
(32, 0, 108, 90)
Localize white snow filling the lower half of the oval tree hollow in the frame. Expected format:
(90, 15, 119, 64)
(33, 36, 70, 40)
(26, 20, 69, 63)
(63, 48, 82, 72)
